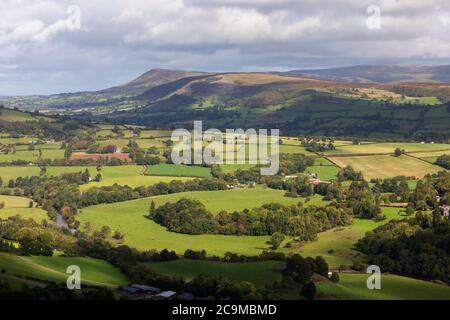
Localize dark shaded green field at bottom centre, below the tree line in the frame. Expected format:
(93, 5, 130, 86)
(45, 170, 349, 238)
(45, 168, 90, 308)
(146, 259, 285, 287)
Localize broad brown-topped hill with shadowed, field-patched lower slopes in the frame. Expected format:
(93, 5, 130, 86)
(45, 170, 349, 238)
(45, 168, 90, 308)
(100, 73, 450, 140)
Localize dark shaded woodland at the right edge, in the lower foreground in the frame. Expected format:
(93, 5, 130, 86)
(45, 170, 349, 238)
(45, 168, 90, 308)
(357, 215, 450, 283)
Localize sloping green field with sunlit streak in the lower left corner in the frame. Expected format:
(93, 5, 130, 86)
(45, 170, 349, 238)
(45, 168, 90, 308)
(0, 253, 128, 287)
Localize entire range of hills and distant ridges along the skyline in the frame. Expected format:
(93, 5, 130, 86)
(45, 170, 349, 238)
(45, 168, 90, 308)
(5, 66, 450, 141)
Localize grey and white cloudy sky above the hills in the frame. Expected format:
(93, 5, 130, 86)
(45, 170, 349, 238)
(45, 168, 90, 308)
(0, 0, 450, 95)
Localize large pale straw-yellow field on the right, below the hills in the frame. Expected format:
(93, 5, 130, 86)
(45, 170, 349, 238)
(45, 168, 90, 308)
(329, 155, 443, 180)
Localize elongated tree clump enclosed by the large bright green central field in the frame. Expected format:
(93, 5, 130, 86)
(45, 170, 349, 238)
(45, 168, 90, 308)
(149, 198, 352, 241)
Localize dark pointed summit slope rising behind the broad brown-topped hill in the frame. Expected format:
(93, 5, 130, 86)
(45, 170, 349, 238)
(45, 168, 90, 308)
(100, 69, 209, 95)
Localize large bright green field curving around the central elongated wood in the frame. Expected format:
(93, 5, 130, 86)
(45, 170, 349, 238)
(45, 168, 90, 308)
(77, 188, 322, 256)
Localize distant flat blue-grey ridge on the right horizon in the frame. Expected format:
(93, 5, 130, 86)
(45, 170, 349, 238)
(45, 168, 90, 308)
(286, 65, 450, 83)
